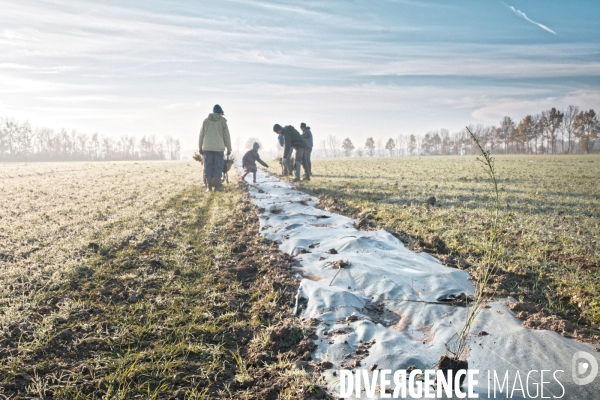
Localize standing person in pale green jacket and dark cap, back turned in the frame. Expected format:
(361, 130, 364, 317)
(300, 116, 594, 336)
(198, 104, 231, 192)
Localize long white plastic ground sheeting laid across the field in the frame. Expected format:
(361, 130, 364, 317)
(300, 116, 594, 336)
(241, 167, 600, 399)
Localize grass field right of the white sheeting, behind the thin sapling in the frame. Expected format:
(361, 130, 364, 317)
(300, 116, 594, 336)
(272, 155, 600, 338)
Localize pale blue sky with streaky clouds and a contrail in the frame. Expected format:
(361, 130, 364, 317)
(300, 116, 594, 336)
(0, 0, 600, 153)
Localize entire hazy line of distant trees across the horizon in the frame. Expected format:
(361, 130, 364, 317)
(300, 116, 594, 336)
(0, 106, 600, 161)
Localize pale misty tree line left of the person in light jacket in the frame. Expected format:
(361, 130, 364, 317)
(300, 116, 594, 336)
(0, 118, 181, 161)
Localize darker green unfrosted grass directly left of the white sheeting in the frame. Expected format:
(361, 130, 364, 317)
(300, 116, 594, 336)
(0, 164, 326, 399)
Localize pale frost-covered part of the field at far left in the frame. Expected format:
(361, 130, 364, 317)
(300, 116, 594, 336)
(0, 162, 197, 332)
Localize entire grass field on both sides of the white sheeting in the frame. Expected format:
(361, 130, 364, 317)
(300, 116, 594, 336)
(0, 156, 600, 399)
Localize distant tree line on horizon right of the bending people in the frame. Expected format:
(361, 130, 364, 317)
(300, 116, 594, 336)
(316, 105, 600, 157)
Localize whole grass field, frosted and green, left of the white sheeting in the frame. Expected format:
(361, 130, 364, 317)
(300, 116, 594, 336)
(0, 162, 324, 399)
